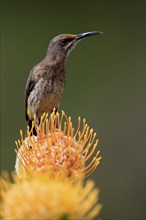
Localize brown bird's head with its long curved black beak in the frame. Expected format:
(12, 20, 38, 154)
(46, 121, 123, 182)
(47, 31, 102, 62)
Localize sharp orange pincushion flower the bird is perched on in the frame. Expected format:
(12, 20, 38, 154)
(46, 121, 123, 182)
(15, 111, 101, 178)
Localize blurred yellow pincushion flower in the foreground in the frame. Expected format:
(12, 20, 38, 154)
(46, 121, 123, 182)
(1, 173, 101, 220)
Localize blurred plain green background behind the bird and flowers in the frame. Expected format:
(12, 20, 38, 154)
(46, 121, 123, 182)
(1, 0, 145, 220)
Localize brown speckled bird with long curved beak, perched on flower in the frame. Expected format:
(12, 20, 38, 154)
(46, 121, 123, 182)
(24, 31, 102, 135)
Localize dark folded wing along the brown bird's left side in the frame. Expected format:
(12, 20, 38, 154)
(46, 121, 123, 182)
(25, 76, 35, 121)
